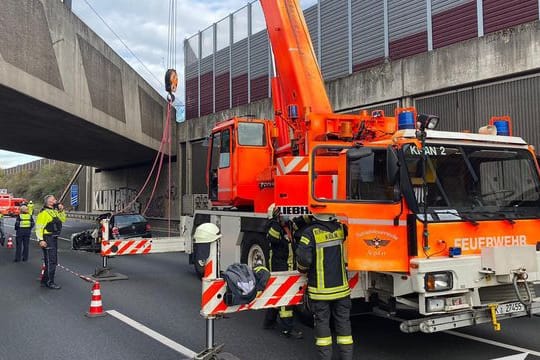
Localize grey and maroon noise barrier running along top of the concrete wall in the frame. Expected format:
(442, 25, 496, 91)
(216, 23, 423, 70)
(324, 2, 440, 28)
(184, 0, 540, 119)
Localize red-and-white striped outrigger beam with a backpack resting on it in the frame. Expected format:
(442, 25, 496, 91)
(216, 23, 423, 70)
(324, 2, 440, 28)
(201, 271, 307, 317)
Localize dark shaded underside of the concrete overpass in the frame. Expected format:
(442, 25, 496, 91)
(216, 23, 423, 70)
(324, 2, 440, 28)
(0, 86, 156, 169)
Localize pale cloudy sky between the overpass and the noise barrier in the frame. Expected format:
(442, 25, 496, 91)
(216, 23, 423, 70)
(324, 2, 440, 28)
(0, 0, 317, 168)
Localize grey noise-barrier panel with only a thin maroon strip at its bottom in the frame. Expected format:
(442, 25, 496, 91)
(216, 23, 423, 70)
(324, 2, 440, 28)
(351, 0, 384, 71)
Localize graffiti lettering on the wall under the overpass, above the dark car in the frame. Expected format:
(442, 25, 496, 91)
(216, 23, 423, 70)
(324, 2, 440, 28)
(92, 188, 141, 213)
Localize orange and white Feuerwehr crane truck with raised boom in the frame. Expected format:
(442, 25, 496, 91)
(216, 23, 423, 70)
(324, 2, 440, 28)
(183, 0, 540, 333)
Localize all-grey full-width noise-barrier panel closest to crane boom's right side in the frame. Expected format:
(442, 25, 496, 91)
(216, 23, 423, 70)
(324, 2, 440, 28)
(320, 0, 349, 80)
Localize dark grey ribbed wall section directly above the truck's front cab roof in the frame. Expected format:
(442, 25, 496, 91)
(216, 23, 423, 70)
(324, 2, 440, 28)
(415, 75, 540, 149)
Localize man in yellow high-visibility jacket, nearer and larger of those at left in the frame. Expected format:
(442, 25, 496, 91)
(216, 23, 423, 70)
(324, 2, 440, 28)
(36, 195, 66, 290)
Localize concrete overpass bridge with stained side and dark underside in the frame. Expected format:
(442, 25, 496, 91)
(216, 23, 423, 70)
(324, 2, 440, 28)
(0, 0, 175, 169)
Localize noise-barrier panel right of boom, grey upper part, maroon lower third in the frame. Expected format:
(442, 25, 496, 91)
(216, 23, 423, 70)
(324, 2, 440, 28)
(388, 0, 428, 59)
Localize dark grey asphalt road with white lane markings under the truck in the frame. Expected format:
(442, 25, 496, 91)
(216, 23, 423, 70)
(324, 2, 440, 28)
(0, 219, 540, 360)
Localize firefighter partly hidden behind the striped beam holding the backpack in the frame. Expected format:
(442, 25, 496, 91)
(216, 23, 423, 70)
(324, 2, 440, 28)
(263, 204, 303, 339)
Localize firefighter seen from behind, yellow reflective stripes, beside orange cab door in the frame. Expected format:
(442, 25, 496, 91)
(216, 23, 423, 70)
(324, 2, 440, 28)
(296, 214, 353, 360)
